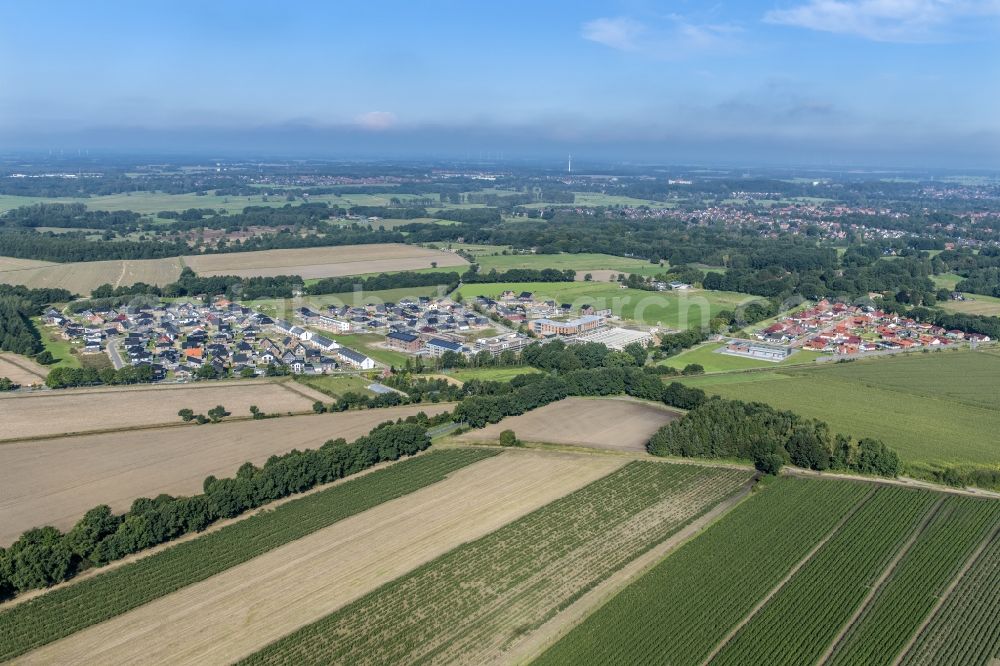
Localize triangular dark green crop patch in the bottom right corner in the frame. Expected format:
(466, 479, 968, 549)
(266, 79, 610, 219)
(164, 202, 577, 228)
(902, 532, 1000, 666)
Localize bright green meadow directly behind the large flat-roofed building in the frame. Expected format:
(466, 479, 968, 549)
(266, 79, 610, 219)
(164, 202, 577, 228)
(459, 282, 755, 329)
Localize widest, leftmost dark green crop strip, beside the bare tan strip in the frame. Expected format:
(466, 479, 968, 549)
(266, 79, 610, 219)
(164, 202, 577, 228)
(535, 477, 870, 666)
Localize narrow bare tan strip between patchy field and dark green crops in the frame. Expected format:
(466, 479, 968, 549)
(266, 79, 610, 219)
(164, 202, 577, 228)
(501, 474, 759, 664)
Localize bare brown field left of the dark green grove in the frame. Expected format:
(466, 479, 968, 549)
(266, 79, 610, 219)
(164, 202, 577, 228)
(459, 398, 679, 451)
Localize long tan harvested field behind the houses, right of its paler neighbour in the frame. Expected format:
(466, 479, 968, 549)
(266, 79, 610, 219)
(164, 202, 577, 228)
(184, 243, 468, 279)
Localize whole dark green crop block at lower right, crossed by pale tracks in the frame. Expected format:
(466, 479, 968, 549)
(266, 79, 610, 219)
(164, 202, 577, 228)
(536, 477, 1000, 666)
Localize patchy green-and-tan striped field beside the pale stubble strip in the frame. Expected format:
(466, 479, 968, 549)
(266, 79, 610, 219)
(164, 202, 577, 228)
(238, 462, 749, 664)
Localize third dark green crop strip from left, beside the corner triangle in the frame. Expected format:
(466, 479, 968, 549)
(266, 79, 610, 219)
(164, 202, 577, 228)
(830, 496, 1000, 666)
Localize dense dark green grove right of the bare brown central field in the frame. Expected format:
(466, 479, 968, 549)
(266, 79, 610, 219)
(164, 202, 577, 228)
(646, 398, 900, 477)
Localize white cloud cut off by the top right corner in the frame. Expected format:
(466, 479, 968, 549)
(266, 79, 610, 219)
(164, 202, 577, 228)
(764, 0, 1000, 42)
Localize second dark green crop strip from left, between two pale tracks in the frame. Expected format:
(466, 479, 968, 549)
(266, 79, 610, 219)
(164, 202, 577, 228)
(712, 487, 938, 665)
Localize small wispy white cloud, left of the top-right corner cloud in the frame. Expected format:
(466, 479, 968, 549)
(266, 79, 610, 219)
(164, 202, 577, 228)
(581, 15, 739, 58)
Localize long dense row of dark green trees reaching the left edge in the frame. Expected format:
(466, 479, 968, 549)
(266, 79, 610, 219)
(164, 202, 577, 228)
(0, 414, 430, 598)
